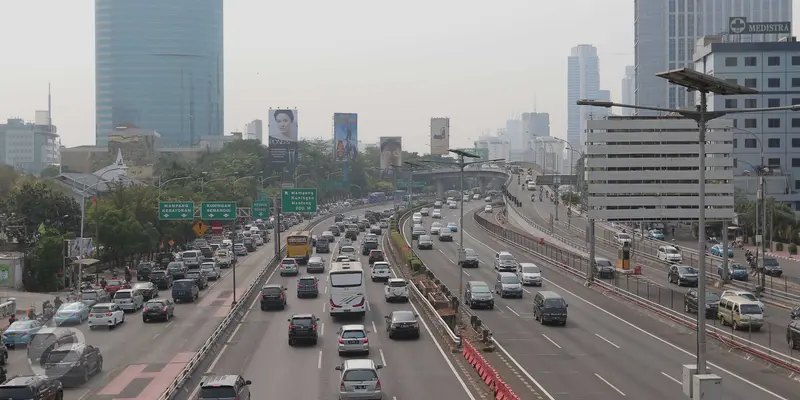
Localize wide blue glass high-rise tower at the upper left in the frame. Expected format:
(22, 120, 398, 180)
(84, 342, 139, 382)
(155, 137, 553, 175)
(95, 0, 224, 147)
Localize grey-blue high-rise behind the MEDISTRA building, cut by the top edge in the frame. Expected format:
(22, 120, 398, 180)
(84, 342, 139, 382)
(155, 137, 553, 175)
(634, 0, 792, 115)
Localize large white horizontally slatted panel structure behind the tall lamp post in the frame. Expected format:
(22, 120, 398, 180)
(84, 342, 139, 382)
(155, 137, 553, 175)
(586, 116, 734, 222)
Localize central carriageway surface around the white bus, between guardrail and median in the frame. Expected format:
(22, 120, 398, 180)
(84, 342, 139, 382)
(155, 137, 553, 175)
(189, 207, 476, 400)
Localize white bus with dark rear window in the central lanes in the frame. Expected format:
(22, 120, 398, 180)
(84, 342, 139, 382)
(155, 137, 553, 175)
(328, 261, 367, 317)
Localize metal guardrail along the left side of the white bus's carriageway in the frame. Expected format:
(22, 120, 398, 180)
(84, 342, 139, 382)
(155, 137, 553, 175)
(158, 202, 400, 400)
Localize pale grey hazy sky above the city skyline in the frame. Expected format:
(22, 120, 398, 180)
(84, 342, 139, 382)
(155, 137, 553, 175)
(0, 0, 788, 152)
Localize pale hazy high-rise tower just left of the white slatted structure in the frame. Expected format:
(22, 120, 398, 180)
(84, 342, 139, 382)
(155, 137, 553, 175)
(567, 44, 610, 151)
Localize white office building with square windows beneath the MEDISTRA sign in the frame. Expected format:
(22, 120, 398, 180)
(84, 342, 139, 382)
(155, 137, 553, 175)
(695, 36, 800, 211)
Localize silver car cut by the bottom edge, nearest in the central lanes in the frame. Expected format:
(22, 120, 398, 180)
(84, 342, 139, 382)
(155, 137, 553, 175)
(336, 359, 383, 400)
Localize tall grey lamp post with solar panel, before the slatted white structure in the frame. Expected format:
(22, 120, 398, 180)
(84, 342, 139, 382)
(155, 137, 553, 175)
(577, 68, 800, 375)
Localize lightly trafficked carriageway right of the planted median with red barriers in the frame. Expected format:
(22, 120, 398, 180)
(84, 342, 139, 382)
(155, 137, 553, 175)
(404, 202, 796, 399)
